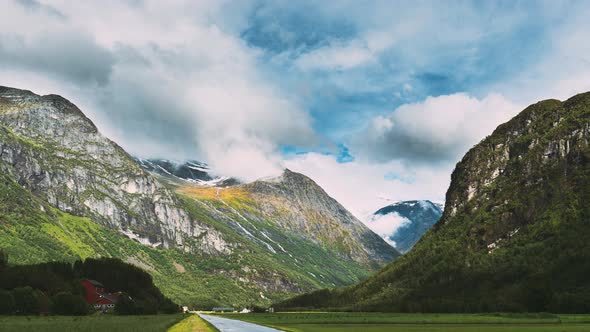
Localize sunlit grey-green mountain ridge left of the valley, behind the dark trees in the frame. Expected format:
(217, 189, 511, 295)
(0, 87, 398, 308)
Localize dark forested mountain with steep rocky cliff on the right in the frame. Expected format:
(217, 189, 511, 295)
(279, 93, 590, 312)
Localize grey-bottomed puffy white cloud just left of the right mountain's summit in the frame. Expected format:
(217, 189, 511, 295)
(354, 93, 520, 163)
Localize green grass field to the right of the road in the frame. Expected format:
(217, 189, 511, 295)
(217, 313, 590, 332)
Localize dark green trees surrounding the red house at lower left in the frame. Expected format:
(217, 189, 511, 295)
(0, 250, 179, 315)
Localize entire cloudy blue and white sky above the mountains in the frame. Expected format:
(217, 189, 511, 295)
(0, 0, 590, 223)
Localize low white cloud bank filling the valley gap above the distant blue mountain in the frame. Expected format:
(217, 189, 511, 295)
(283, 153, 454, 221)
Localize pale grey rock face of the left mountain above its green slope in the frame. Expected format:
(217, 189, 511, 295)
(0, 87, 230, 253)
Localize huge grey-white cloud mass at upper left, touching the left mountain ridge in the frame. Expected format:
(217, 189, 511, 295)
(0, 1, 316, 180)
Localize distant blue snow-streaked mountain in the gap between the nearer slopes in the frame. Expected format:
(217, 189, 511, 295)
(368, 200, 444, 253)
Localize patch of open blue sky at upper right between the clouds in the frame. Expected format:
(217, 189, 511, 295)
(240, 1, 563, 141)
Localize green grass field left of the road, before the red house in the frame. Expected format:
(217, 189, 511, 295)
(0, 314, 186, 332)
